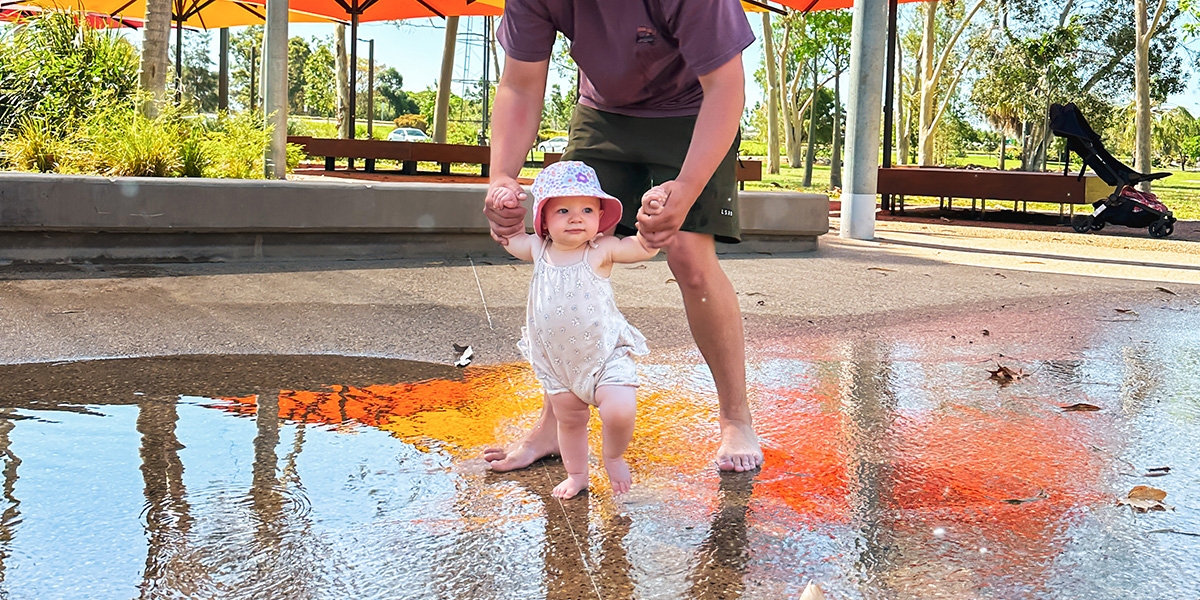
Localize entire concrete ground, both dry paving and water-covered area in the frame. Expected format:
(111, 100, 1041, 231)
(0, 225, 1200, 599)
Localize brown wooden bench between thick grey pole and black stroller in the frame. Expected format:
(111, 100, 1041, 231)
(877, 167, 1112, 217)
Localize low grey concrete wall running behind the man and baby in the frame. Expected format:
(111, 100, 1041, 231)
(0, 173, 829, 263)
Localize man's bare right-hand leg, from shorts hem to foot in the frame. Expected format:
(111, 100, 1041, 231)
(667, 232, 762, 470)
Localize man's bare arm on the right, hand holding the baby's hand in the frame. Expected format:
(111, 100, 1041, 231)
(637, 54, 745, 248)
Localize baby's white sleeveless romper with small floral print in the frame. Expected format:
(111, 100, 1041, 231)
(517, 240, 649, 406)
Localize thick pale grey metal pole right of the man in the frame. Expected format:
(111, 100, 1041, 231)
(841, 0, 889, 240)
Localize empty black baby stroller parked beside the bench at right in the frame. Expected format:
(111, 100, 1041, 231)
(1050, 102, 1176, 238)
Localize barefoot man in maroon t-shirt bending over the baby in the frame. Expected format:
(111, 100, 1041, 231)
(484, 0, 763, 472)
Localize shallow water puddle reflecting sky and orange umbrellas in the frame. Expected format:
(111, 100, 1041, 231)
(0, 307, 1200, 599)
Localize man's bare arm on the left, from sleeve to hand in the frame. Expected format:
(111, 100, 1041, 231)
(484, 58, 550, 245)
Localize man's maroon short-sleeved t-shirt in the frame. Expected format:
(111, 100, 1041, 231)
(498, 0, 754, 116)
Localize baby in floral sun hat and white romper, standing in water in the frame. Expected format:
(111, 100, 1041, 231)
(504, 161, 666, 498)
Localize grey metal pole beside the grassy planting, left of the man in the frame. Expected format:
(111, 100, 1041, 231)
(263, 0, 288, 179)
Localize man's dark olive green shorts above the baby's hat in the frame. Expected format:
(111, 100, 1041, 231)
(563, 104, 742, 244)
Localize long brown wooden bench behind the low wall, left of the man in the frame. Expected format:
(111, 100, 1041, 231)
(288, 136, 492, 178)
